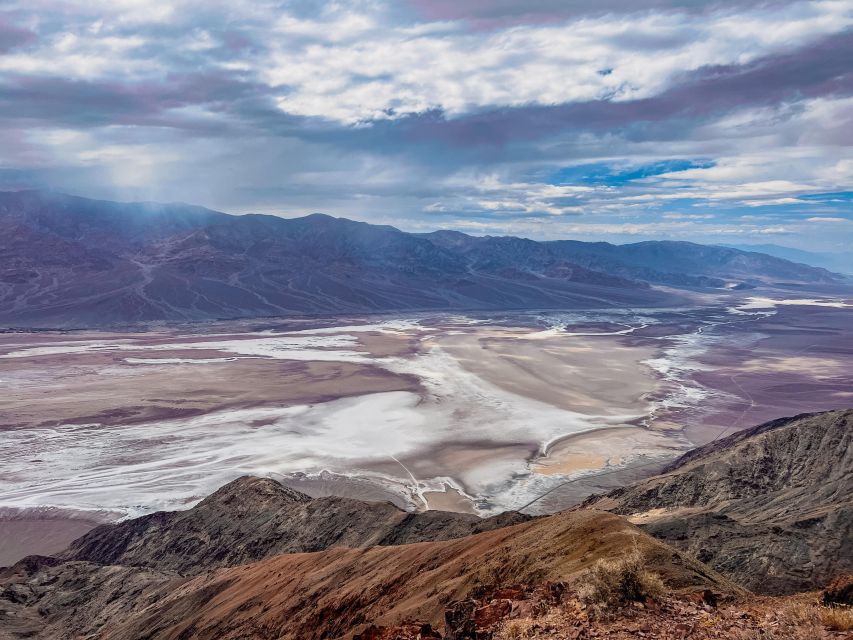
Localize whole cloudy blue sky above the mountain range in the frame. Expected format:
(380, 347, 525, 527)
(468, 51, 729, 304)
(0, 0, 853, 251)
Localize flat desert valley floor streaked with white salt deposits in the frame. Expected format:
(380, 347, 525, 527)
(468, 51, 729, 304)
(0, 295, 853, 565)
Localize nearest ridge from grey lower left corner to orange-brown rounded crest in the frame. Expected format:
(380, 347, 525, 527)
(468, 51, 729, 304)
(0, 510, 743, 640)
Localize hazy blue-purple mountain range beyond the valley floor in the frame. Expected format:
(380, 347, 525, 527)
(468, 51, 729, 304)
(0, 191, 839, 327)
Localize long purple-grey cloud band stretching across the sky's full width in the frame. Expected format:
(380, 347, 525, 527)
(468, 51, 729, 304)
(0, 26, 853, 151)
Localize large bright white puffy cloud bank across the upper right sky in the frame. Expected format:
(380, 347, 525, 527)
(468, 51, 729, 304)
(260, 2, 853, 124)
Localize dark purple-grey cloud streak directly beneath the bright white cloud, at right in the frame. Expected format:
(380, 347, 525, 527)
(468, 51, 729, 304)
(394, 31, 853, 148)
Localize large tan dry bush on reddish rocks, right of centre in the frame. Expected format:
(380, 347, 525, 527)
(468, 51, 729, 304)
(577, 549, 667, 608)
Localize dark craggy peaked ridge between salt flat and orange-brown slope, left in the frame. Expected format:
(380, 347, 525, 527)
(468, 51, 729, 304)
(60, 476, 530, 575)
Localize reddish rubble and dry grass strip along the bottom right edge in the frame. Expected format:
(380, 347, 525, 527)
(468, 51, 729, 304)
(353, 583, 850, 640)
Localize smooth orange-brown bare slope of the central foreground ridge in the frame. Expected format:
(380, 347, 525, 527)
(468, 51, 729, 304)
(95, 511, 743, 640)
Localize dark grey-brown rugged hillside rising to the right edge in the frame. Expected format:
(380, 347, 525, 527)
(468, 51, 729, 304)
(583, 410, 853, 594)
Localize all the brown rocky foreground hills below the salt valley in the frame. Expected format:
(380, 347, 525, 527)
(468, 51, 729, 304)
(0, 411, 853, 640)
